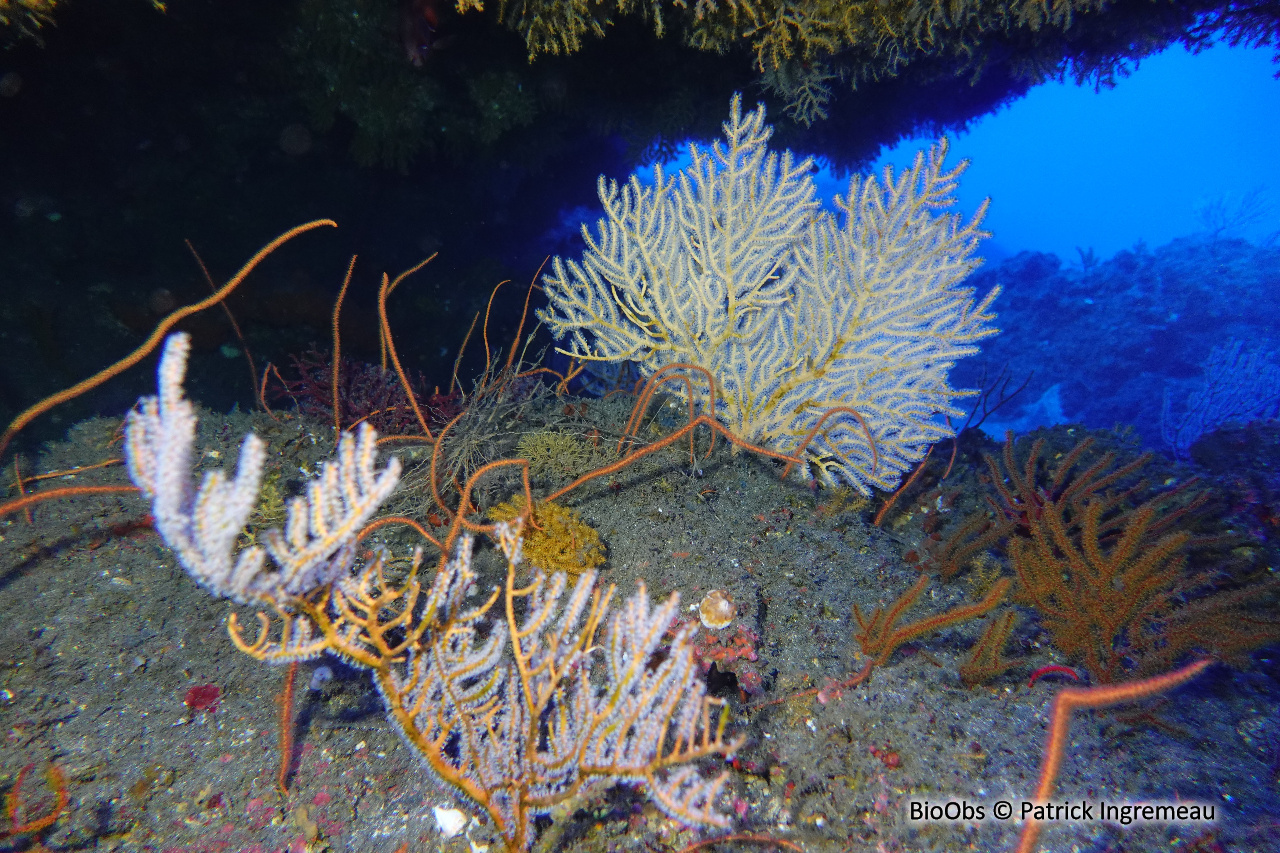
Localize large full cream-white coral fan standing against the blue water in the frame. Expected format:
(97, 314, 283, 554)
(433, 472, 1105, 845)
(539, 96, 997, 493)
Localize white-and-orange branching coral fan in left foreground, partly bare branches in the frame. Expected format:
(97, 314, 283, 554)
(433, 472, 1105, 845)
(125, 334, 741, 853)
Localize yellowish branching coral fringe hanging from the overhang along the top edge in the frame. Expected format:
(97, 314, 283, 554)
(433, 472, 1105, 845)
(457, 0, 1280, 124)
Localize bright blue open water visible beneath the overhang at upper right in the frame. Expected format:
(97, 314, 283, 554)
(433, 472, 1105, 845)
(624, 45, 1280, 261)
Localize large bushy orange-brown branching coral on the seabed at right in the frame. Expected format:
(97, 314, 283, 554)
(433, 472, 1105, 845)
(938, 435, 1280, 683)
